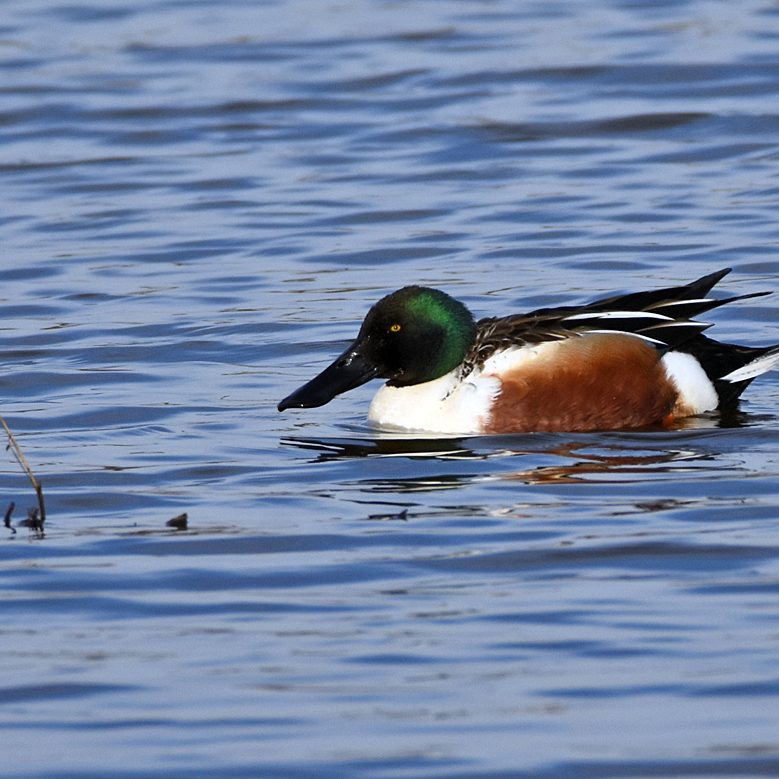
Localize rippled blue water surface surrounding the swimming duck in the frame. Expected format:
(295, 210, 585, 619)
(0, 0, 779, 779)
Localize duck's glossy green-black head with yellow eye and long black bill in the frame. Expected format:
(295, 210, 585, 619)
(279, 286, 476, 411)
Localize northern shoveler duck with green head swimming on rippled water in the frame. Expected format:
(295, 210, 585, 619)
(278, 268, 779, 434)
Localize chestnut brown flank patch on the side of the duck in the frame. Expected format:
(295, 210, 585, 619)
(485, 333, 677, 433)
